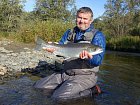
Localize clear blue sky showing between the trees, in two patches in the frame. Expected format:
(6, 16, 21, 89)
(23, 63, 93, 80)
(24, 0, 107, 18)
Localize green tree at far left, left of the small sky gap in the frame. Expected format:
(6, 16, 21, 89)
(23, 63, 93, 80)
(0, 0, 23, 32)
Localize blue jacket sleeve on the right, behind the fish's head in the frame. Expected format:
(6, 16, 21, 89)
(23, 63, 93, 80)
(89, 31, 106, 66)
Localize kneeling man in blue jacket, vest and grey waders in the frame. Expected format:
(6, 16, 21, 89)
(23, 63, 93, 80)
(34, 7, 106, 100)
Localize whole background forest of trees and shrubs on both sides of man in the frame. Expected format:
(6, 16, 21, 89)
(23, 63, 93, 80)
(0, 0, 140, 52)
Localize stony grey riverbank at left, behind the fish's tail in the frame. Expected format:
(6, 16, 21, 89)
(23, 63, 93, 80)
(0, 39, 62, 79)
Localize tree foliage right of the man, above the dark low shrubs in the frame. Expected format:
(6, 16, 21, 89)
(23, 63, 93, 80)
(100, 0, 140, 36)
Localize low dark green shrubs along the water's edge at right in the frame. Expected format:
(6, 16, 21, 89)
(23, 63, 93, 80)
(107, 36, 140, 52)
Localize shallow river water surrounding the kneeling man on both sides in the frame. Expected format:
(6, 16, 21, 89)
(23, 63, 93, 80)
(0, 52, 140, 105)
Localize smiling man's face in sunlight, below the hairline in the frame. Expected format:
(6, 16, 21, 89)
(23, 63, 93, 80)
(76, 13, 93, 31)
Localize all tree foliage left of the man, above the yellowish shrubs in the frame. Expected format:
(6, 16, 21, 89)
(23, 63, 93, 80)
(0, 0, 76, 33)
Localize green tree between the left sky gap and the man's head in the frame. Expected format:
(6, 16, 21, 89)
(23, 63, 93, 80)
(34, 0, 75, 20)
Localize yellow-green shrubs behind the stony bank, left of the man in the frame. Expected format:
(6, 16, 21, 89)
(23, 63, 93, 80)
(15, 20, 73, 43)
